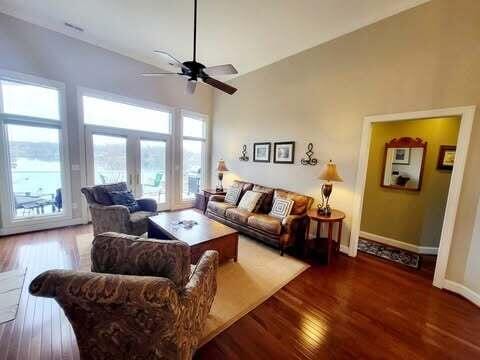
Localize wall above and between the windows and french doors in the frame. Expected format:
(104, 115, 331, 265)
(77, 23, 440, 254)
(0, 13, 212, 226)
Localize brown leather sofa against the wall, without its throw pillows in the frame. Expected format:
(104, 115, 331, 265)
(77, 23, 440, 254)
(206, 181, 313, 255)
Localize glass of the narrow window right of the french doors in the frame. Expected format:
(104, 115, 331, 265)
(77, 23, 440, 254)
(182, 115, 206, 200)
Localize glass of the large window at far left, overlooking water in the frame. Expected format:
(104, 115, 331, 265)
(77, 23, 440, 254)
(0, 76, 68, 223)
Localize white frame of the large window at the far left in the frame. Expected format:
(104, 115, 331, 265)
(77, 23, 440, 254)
(0, 69, 72, 231)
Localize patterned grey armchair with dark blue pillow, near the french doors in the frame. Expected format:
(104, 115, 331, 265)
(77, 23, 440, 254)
(81, 182, 157, 235)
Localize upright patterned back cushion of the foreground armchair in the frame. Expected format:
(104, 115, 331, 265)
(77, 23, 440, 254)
(91, 232, 190, 287)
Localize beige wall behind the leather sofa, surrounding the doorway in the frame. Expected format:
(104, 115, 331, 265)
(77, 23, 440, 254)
(212, 0, 480, 292)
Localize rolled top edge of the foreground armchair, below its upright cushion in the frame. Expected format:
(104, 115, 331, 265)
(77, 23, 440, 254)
(29, 270, 177, 310)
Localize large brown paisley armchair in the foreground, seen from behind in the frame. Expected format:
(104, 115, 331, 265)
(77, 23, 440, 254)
(29, 233, 218, 360)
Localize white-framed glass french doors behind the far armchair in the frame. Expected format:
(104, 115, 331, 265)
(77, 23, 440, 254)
(86, 125, 171, 210)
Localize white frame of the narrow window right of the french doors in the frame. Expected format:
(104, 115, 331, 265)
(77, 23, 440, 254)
(178, 110, 210, 207)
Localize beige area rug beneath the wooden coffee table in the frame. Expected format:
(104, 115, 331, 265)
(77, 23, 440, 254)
(77, 234, 309, 345)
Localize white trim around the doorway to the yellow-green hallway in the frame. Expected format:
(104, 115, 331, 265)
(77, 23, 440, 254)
(349, 106, 476, 288)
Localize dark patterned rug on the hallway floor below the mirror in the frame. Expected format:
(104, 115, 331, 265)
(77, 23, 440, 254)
(358, 239, 420, 269)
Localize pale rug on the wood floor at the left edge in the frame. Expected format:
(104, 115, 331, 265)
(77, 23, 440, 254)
(0, 269, 26, 324)
